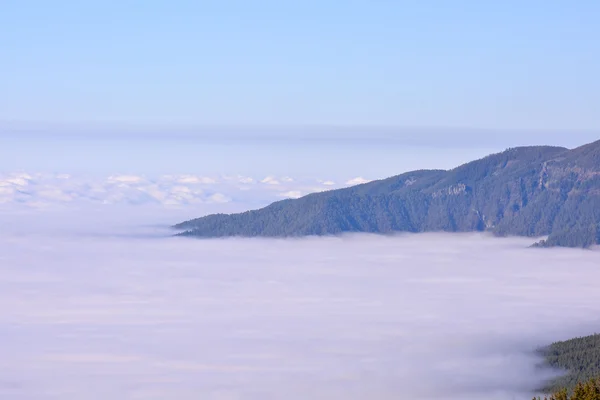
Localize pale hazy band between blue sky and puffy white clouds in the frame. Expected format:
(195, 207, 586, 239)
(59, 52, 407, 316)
(0, 127, 600, 181)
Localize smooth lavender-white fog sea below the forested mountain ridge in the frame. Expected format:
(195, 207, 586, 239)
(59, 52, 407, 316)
(0, 203, 600, 400)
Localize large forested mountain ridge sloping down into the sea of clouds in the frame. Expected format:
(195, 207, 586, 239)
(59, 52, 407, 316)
(175, 141, 600, 247)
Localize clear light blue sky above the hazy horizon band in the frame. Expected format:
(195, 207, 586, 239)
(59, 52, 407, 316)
(0, 0, 600, 130)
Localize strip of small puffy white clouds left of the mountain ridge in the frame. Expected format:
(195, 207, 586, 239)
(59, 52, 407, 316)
(0, 172, 356, 207)
